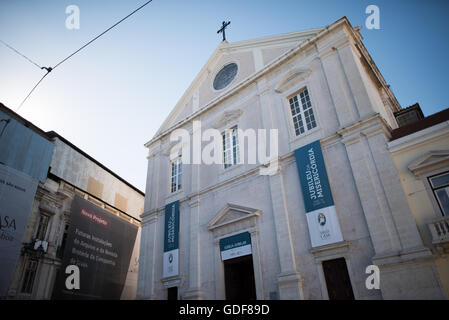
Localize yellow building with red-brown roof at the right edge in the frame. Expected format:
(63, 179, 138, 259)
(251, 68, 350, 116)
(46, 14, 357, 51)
(388, 109, 449, 294)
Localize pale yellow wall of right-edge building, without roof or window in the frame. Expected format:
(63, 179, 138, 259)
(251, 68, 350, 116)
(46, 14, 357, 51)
(388, 121, 449, 295)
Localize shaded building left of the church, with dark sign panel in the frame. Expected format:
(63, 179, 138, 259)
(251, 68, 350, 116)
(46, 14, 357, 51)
(0, 105, 144, 299)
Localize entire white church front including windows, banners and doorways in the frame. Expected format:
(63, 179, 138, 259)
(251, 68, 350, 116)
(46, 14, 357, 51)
(137, 17, 447, 299)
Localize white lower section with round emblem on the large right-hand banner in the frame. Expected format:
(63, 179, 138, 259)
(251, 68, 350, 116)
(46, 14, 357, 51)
(306, 206, 343, 247)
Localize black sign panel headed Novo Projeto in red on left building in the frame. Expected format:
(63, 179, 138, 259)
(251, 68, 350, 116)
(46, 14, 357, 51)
(53, 196, 138, 299)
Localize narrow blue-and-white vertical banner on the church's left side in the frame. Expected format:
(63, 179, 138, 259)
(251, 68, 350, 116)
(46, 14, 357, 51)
(162, 200, 179, 278)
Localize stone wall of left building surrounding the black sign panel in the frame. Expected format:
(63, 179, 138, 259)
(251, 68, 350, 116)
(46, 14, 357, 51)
(8, 138, 144, 300)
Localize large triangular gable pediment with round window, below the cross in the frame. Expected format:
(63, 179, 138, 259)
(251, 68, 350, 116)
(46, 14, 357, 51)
(149, 28, 323, 145)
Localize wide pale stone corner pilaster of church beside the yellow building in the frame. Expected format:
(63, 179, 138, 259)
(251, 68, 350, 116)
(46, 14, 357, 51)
(339, 116, 445, 299)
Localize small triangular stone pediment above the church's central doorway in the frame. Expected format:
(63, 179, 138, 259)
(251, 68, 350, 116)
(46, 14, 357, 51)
(207, 203, 261, 230)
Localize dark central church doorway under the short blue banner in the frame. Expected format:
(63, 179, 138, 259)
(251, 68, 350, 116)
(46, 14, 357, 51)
(224, 254, 257, 300)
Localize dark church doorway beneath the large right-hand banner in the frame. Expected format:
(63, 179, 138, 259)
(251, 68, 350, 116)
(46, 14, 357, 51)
(323, 258, 354, 300)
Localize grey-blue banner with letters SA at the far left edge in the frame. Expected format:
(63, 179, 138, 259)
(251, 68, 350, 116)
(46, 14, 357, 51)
(0, 164, 38, 298)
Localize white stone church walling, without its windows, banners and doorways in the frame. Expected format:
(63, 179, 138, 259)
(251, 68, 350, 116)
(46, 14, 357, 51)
(137, 18, 446, 299)
